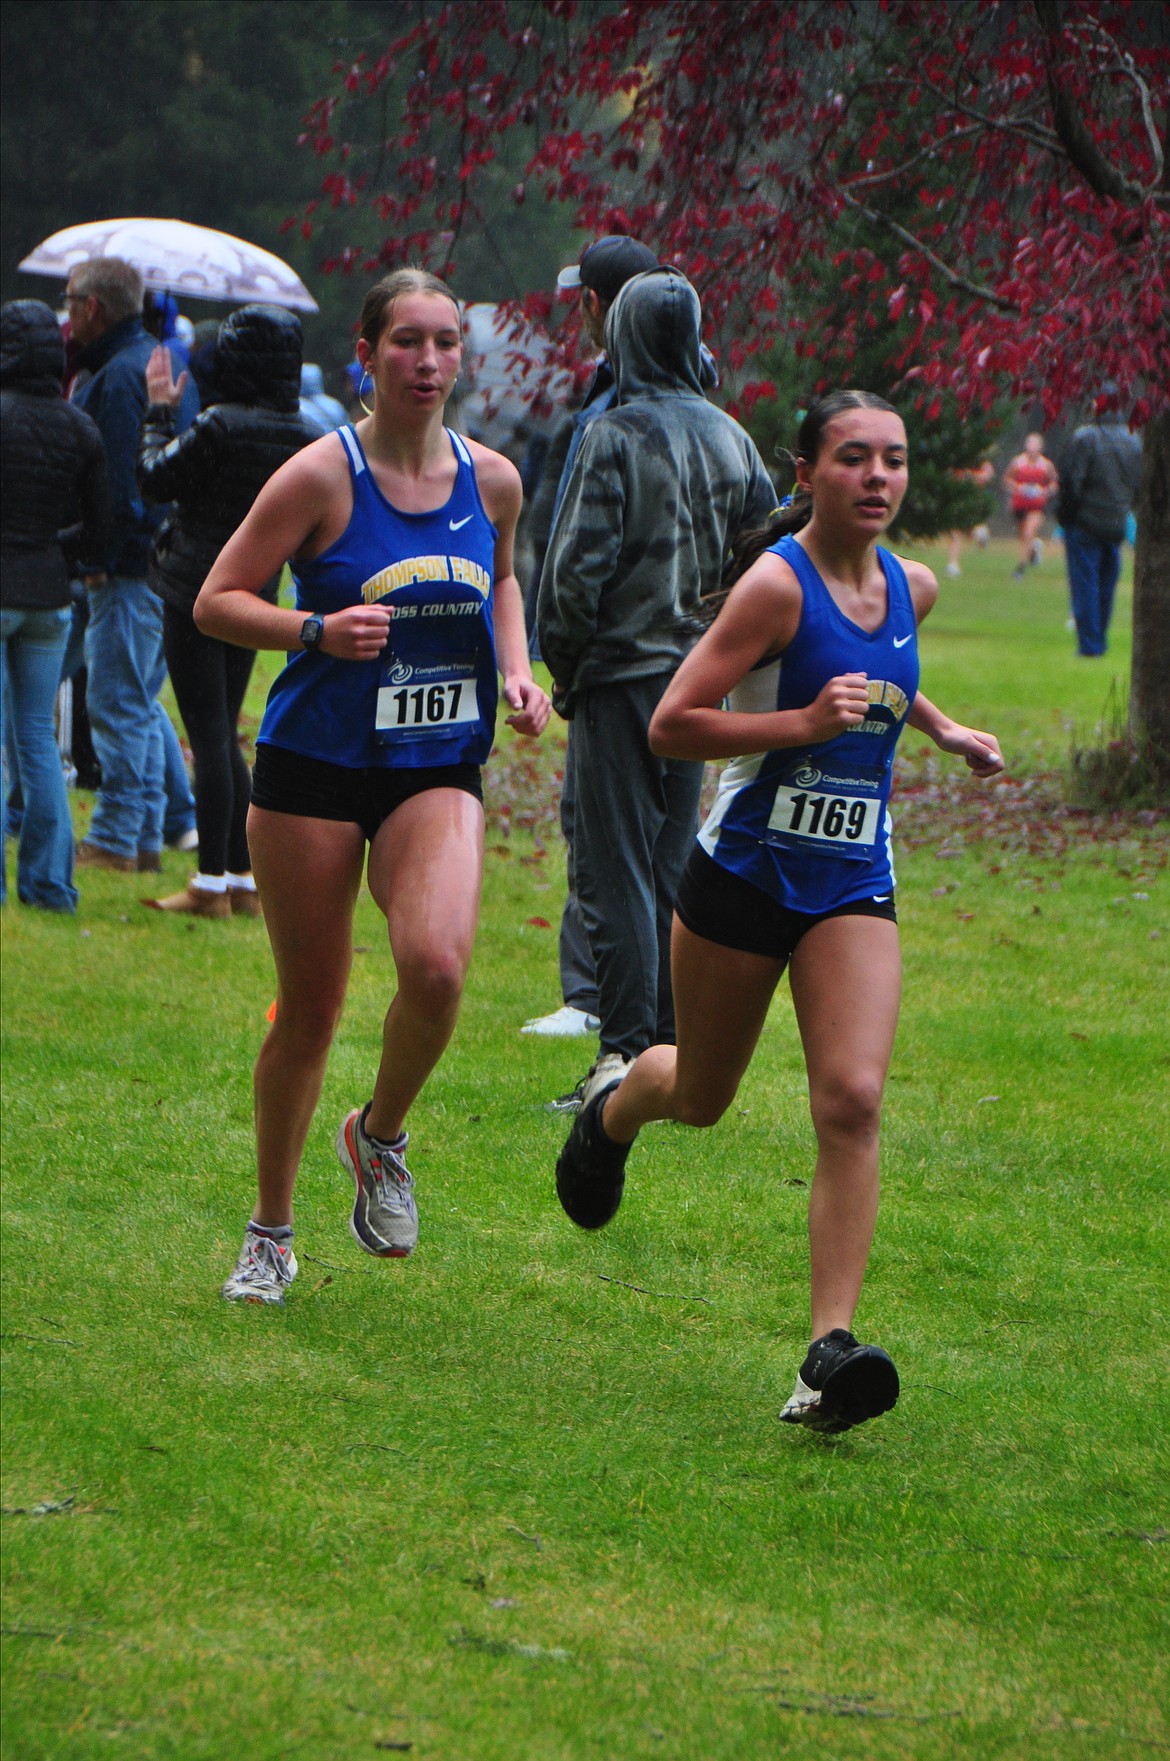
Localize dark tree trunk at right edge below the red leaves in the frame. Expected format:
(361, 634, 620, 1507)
(1129, 410, 1170, 791)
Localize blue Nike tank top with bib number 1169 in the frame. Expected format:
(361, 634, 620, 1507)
(700, 537, 918, 912)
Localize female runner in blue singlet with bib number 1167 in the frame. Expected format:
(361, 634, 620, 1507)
(196, 269, 550, 1303)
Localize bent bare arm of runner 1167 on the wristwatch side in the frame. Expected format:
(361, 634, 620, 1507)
(194, 435, 389, 660)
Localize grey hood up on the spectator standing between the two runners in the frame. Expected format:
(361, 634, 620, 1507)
(606, 268, 703, 403)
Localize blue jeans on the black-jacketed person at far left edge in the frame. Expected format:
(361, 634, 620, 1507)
(0, 606, 78, 910)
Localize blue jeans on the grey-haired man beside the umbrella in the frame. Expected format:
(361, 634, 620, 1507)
(85, 576, 166, 856)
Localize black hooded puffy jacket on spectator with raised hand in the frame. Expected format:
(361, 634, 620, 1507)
(137, 306, 321, 613)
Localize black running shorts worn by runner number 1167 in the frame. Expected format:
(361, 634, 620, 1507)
(252, 741, 483, 844)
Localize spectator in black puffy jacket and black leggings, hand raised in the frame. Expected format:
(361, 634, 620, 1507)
(137, 305, 321, 917)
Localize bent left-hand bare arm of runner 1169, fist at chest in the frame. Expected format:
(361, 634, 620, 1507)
(650, 551, 867, 759)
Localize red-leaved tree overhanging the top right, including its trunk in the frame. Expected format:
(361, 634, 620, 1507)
(297, 0, 1170, 778)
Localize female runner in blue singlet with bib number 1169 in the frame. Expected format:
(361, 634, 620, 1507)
(557, 391, 1003, 1432)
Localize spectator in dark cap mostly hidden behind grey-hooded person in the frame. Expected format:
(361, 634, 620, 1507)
(520, 232, 657, 1049)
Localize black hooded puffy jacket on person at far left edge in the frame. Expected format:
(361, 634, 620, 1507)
(0, 299, 109, 611)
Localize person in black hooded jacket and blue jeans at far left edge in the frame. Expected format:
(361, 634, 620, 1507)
(0, 299, 109, 910)
